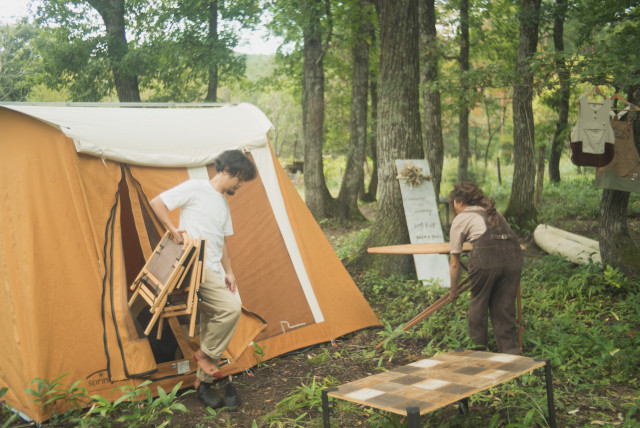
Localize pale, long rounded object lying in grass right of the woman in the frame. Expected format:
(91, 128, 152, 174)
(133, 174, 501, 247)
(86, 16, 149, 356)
(533, 224, 601, 265)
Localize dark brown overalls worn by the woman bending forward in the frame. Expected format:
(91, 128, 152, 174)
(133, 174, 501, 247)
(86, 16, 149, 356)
(468, 214, 523, 354)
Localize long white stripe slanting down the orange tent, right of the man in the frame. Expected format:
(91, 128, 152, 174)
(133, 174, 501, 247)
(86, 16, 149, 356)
(251, 147, 324, 323)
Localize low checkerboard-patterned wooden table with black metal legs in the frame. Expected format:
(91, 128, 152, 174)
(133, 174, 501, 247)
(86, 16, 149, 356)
(322, 350, 556, 428)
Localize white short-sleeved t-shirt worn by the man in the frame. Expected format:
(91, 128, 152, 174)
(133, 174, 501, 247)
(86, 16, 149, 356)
(160, 180, 233, 275)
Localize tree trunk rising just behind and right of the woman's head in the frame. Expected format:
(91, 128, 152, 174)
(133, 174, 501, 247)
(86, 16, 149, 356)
(505, 0, 540, 229)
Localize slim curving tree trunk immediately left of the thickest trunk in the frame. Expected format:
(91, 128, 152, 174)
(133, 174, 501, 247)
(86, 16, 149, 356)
(337, 0, 371, 219)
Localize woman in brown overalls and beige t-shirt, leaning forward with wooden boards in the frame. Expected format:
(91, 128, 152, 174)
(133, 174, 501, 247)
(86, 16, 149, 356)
(449, 182, 523, 355)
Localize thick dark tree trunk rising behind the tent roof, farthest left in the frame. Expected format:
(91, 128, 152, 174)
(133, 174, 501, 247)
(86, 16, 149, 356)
(89, 0, 140, 102)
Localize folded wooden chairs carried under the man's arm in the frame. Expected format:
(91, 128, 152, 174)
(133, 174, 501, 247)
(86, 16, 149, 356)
(129, 232, 206, 339)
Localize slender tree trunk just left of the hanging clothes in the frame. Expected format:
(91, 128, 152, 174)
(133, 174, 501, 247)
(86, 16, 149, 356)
(549, 0, 571, 183)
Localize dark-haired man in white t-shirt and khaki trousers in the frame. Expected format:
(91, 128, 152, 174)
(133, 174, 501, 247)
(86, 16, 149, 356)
(151, 150, 256, 408)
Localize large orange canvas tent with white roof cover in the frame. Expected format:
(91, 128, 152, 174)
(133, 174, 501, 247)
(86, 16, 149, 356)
(0, 103, 379, 421)
